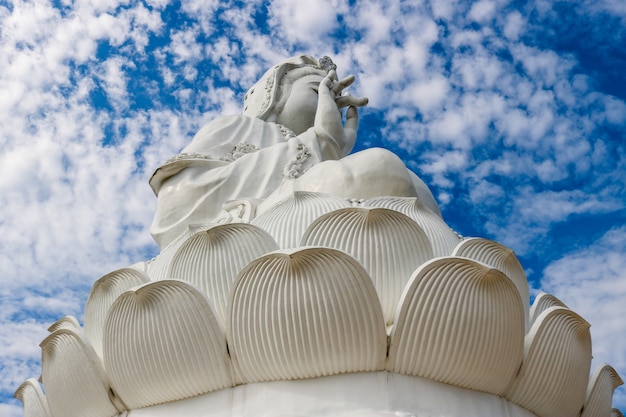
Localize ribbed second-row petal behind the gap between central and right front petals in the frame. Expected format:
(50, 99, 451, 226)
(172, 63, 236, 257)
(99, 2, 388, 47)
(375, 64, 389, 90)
(301, 208, 433, 326)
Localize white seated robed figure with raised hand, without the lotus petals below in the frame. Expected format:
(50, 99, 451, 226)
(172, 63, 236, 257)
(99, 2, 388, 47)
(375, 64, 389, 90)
(150, 56, 438, 248)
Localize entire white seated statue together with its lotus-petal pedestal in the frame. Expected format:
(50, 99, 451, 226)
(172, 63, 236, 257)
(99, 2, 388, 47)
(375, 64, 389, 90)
(15, 56, 622, 417)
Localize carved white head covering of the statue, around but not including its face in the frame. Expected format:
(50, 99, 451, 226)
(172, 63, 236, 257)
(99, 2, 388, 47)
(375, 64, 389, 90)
(243, 55, 337, 121)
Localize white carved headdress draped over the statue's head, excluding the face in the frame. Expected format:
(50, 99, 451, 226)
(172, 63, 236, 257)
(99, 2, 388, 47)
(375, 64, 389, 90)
(243, 55, 337, 120)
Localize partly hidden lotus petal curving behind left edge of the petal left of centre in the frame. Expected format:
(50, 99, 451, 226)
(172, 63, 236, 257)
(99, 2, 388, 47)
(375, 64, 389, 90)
(85, 268, 149, 358)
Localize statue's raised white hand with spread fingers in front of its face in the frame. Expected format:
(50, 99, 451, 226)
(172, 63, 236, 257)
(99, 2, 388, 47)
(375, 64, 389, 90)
(314, 71, 368, 156)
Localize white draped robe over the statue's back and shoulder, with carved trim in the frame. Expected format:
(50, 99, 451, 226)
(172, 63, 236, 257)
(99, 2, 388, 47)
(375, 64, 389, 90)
(150, 116, 332, 248)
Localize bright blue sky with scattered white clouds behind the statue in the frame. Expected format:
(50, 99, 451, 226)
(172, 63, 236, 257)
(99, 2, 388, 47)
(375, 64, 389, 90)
(0, 0, 626, 417)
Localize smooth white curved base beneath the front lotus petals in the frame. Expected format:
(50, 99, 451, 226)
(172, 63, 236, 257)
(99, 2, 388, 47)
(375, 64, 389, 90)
(128, 372, 535, 417)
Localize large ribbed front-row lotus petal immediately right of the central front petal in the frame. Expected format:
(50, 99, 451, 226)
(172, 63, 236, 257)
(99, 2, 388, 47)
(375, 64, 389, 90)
(387, 257, 524, 395)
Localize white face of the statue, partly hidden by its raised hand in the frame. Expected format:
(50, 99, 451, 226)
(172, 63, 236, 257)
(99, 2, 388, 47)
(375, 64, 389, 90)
(275, 72, 324, 135)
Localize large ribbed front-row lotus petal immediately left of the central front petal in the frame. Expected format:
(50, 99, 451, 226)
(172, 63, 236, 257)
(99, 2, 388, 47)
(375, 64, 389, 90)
(103, 280, 232, 409)
